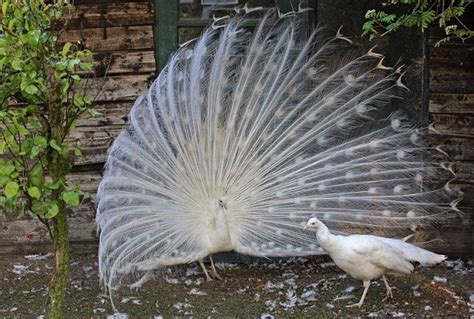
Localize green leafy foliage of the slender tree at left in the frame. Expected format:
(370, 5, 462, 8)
(0, 0, 93, 224)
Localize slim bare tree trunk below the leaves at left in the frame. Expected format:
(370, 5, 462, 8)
(48, 210, 70, 319)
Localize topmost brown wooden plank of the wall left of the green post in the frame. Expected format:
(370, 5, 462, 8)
(66, 2, 154, 30)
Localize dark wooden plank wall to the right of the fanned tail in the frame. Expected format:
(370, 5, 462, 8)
(429, 34, 474, 256)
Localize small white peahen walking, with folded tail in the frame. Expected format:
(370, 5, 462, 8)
(304, 217, 446, 307)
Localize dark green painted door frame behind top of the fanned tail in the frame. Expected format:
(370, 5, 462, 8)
(153, 0, 306, 74)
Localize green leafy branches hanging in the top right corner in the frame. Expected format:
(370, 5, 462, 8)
(362, 0, 474, 47)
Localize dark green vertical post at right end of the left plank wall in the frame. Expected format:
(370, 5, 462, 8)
(154, 0, 179, 73)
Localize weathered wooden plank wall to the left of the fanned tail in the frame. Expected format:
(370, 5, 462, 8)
(0, 0, 155, 253)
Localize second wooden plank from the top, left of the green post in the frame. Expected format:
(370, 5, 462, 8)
(60, 25, 153, 52)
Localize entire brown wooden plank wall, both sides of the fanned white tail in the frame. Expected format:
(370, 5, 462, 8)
(0, 0, 474, 255)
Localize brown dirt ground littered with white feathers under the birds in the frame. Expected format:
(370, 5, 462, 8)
(0, 254, 474, 318)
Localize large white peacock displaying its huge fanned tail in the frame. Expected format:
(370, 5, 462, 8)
(97, 8, 454, 289)
